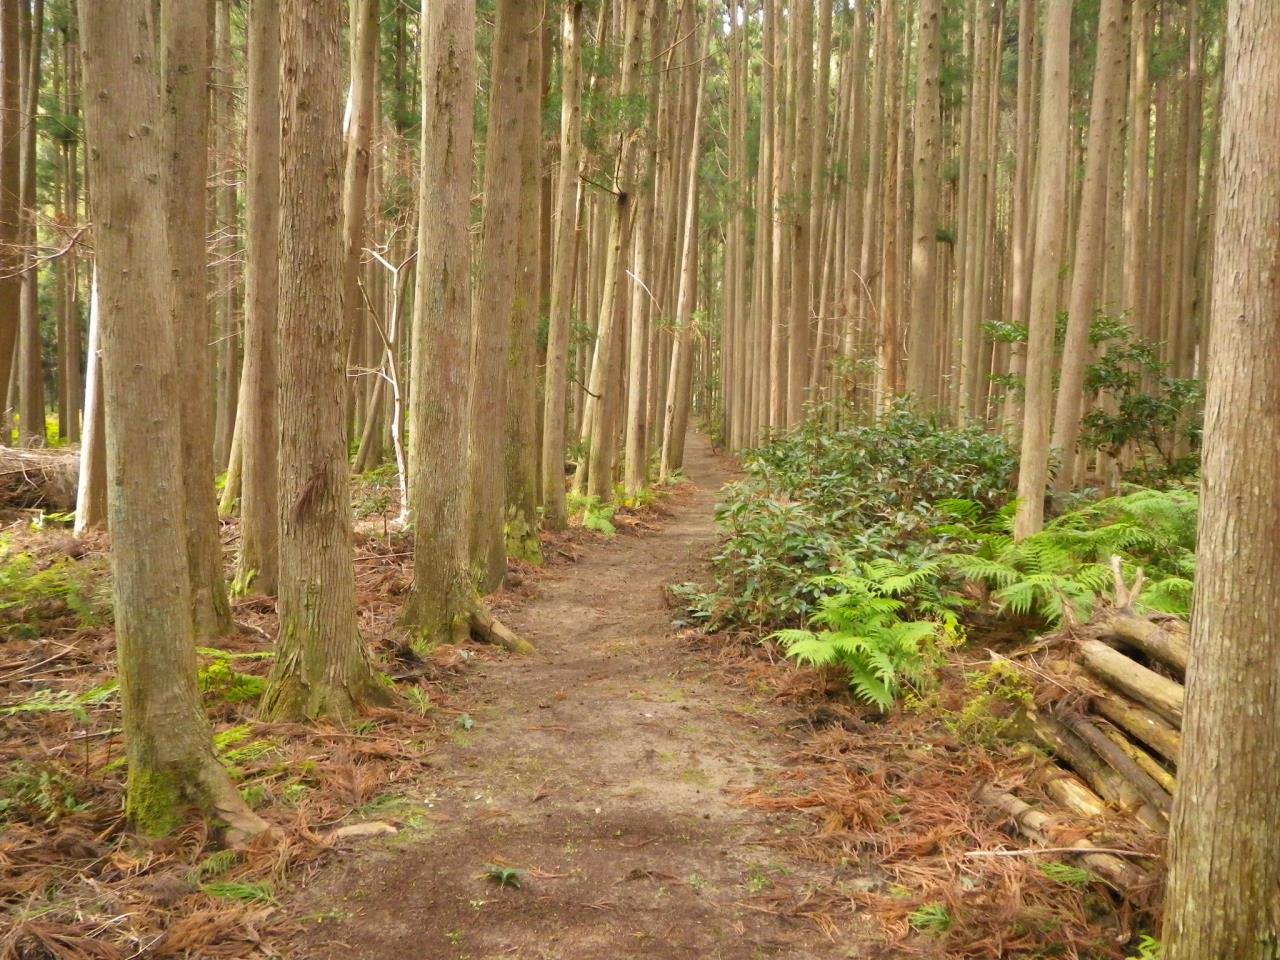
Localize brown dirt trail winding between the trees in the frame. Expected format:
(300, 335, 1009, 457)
(291, 435, 870, 960)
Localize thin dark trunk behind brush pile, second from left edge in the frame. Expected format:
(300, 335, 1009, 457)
(18, 0, 47, 447)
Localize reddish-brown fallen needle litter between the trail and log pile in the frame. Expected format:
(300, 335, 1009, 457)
(690, 632, 1158, 960)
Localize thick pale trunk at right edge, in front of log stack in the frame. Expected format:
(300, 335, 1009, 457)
(1165, 0, 1280, 960)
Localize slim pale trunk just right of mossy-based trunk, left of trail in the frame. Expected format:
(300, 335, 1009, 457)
(541, 0, 582, 530)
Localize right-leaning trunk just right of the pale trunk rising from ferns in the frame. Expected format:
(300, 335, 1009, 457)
(1052, 0, 1126, 490)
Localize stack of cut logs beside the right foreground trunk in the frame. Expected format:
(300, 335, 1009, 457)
(980, 568, 1190, 899)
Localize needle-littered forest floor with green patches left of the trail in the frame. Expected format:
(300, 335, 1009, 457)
(0, 525, 529, 960)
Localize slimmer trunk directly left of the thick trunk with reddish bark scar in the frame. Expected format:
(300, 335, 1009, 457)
(237, 0, 280, 595)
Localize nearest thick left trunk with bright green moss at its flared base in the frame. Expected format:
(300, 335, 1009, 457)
(79, 0, 266, 838)
